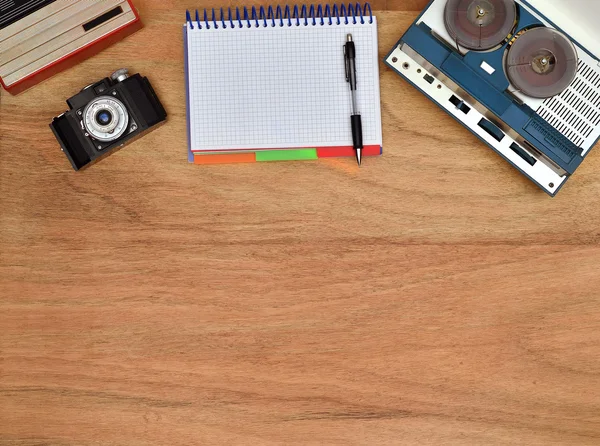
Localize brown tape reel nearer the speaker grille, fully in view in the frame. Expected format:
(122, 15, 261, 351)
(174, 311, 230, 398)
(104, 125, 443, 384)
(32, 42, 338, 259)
(505, 27, 579, 99)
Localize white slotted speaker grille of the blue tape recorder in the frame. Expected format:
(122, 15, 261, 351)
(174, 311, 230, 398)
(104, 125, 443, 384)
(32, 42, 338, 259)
(537, 60, 600, 147)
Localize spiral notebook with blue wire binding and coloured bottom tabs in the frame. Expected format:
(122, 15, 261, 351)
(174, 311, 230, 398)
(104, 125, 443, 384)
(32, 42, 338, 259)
(184, 4, 382, 164)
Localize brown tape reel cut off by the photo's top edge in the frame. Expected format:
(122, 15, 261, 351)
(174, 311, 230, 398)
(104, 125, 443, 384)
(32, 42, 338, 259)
(444, 0, 517, 51)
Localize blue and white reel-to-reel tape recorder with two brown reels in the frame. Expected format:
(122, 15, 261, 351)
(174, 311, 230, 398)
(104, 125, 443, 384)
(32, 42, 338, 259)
(386, 0, 600, 196)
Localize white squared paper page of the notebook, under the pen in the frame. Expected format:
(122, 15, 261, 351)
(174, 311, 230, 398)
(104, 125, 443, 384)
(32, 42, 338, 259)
(187, 17, 382, 151)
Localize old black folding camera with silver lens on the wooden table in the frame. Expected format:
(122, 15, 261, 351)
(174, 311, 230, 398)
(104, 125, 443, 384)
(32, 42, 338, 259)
(50, 69, 167, 170)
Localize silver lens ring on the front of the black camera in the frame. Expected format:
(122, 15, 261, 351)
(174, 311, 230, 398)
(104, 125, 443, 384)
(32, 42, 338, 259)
(83, 96, 129, 142)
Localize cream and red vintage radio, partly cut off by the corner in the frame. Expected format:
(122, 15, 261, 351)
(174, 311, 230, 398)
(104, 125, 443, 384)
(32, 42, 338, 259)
(0, 0, 142, 94)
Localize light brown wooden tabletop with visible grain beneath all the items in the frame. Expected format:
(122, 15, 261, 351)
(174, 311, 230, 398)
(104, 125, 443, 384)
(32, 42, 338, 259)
(0, 0, 600, 445)
